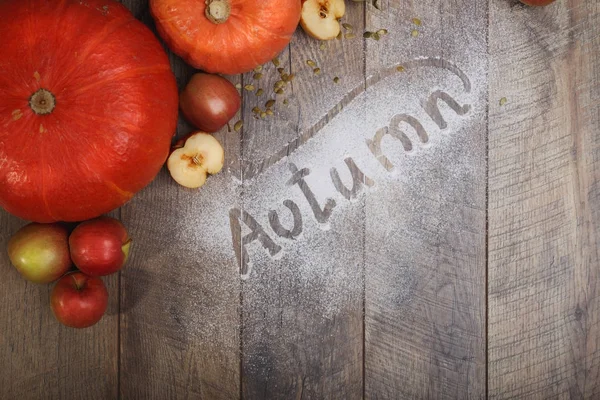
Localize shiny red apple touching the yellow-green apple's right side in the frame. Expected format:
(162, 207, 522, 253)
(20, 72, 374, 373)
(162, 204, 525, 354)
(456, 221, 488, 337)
(69, 217, 131, 276)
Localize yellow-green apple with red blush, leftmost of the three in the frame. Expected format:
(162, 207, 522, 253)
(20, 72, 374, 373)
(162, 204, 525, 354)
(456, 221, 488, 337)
(8, 223, 71, 283)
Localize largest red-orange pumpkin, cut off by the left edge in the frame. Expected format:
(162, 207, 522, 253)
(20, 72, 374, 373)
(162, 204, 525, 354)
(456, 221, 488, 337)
(0, 0, 178, 222)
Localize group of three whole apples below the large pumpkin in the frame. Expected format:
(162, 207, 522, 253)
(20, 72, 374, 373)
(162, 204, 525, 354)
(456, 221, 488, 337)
(8, 217, 131, 328)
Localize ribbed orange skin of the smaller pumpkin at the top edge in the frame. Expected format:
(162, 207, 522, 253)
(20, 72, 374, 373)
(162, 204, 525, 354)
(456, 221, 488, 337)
(150, 0, 301, 75)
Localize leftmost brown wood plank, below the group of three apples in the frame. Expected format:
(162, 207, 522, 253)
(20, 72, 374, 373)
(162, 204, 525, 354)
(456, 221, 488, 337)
(0, 211, 119, 400)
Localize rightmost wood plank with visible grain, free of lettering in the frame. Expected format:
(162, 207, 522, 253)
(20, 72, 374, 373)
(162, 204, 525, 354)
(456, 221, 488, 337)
(489, 0, 600, 399)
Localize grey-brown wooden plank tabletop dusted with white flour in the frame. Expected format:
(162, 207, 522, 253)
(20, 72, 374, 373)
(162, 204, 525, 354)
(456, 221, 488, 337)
(0, 0, 600, 400)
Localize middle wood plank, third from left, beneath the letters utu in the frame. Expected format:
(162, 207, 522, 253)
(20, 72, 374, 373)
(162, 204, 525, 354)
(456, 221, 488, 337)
(241, 2, 364, 399)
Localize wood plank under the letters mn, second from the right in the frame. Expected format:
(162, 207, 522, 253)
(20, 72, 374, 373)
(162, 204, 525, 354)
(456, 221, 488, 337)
(365, 0, 487, 399)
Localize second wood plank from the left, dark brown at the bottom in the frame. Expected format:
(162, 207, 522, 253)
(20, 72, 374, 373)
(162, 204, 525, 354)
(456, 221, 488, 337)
(120, 0, 240, 400)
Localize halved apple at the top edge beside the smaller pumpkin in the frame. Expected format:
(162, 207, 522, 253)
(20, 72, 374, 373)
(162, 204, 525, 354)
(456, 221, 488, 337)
(300, 0, 346, 40)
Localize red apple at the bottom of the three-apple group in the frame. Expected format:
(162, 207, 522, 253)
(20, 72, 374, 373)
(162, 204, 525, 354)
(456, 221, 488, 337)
(50, 272, 108, 328)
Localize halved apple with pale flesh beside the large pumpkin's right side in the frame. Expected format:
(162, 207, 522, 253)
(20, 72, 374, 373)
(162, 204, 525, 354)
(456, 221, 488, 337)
(167, 132, 225, 189)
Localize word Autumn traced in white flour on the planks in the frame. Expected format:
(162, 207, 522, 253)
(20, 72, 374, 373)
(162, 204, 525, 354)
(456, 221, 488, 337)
(229, 59, 471, 279)
